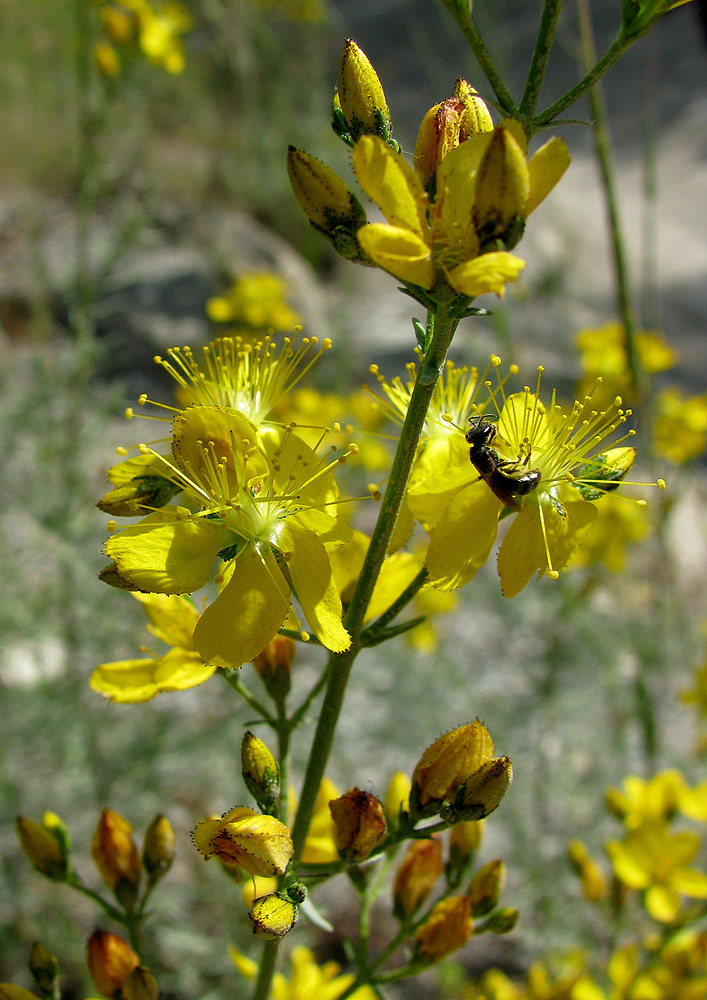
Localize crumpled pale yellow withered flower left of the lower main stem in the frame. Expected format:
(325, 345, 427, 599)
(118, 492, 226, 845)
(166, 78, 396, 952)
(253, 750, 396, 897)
(192, 806, 293, 878)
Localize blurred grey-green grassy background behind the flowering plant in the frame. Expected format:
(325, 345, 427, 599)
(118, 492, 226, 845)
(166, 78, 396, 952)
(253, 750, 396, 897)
(0, 0, 707, 1000)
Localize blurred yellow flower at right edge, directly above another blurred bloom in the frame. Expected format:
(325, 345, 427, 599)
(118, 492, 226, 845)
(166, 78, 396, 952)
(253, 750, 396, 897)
(606, 768, 707, 830)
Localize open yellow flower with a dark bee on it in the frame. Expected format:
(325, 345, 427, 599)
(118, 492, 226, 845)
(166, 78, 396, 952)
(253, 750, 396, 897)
(408, 358, 664, 597)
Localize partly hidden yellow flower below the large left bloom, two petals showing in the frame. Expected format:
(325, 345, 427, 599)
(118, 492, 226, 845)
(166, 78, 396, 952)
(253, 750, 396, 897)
(89, 594, 216, 703)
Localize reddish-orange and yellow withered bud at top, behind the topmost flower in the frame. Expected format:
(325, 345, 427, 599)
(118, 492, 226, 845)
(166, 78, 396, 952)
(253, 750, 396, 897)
(413, 80, 493, 186)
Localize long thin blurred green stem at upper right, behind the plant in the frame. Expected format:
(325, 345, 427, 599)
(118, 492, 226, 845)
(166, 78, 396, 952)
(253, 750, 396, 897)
(578, 0, 640, 391)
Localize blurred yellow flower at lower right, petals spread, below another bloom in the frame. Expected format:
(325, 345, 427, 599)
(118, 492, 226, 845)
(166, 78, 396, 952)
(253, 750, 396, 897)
(606, 822, 707, 923)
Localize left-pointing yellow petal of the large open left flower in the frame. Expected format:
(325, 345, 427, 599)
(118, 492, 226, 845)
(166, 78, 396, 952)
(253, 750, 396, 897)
(106, 507, 228, 594)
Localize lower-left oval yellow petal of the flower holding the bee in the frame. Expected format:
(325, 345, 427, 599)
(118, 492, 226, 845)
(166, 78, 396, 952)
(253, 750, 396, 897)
(427, 482, 502, 590)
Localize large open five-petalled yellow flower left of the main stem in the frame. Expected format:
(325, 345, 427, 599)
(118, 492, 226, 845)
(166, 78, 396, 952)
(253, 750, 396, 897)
(102, 406, 350, 667)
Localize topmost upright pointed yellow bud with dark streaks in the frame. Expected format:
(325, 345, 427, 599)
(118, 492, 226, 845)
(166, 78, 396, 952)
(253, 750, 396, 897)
(335, 38, 393, 142)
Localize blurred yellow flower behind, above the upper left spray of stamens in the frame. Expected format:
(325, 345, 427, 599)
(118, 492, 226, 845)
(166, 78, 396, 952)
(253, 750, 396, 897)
(206, 271, 300, 332)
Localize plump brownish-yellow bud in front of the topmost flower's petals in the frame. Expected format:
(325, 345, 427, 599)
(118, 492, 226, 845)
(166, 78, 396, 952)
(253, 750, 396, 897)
(474, 125, 530, 250)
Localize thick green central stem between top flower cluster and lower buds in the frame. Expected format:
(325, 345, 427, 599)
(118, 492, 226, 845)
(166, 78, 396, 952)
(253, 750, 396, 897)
(292, 306, 457, 865)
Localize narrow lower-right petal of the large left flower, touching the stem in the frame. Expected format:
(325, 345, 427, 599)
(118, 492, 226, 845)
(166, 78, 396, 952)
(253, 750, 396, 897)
(280, 518, 351, 653)
